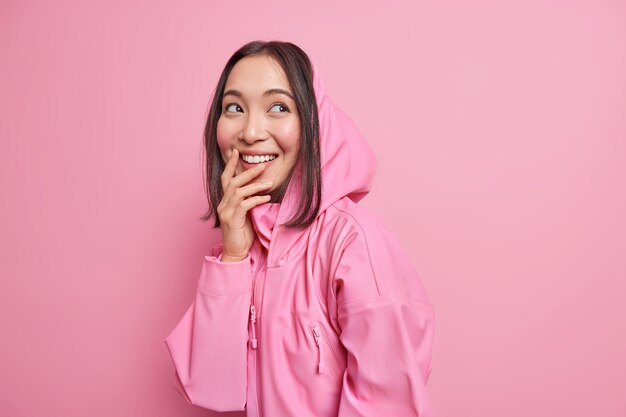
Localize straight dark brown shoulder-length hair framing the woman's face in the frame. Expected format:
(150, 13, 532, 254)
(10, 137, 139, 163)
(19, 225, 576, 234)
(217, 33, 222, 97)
(200, 41, 322, 228)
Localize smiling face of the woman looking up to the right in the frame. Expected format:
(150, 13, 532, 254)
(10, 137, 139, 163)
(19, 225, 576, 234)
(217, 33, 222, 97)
(217, 55, 300, 190)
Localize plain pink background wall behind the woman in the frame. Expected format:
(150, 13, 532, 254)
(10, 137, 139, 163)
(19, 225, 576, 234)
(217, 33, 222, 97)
(0, 0, 626, 417)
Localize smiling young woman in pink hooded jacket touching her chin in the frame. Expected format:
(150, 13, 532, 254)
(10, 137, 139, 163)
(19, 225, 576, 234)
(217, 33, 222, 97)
(165, 41, 435, 417)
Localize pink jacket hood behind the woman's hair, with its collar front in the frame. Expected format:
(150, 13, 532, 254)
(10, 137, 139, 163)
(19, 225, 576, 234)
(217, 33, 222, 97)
(248, 64, 377, 266)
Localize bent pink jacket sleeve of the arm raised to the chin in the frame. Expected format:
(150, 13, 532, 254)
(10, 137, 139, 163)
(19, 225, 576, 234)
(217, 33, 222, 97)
(164, 245, 252, 411)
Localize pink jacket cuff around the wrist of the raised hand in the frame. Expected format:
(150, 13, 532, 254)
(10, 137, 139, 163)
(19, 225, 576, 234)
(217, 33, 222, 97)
(197, 253, 252, 296)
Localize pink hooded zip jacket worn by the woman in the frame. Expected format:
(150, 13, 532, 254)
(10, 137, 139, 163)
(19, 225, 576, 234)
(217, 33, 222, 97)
(165, 61, 435, 417)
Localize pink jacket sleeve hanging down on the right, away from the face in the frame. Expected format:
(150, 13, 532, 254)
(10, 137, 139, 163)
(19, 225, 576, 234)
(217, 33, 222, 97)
(334, 219, 435, 417)
